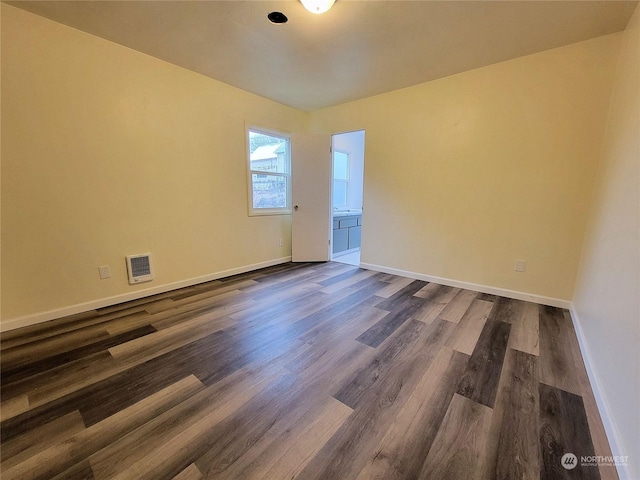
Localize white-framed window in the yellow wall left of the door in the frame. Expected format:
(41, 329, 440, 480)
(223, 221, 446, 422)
(248, 128, 291, 215)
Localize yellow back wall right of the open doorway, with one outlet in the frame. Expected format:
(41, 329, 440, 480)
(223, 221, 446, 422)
(311, 34, 620, 300)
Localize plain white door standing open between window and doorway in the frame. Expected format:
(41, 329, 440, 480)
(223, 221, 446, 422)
(291, 133, 332, 262)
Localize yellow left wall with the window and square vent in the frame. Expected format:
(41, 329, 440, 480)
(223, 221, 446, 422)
(2, 4, 308, 321)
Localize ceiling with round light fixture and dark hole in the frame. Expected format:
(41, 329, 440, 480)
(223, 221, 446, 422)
(6, 0, 637, 111)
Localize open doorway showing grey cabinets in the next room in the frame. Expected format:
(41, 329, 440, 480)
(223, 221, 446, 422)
(331, 130, 365, 266)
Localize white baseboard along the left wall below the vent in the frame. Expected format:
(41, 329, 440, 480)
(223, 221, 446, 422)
(0, 256, 291, 332)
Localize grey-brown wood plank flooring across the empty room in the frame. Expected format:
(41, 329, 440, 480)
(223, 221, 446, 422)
(0, 263, 618, 480)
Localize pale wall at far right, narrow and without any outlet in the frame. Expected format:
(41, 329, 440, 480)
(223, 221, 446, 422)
(574, 4, 640, 478)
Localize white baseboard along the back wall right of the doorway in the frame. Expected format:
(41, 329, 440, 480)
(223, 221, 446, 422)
(360, 263, 571, 309)
